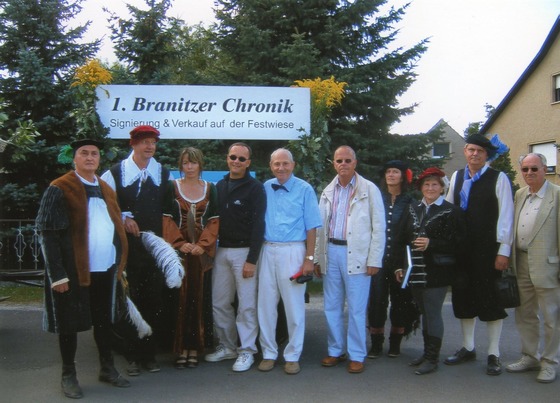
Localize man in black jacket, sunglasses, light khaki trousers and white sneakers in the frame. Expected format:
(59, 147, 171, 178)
(205, 143, 266, 372)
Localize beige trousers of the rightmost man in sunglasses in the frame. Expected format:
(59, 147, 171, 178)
(515, 252, 560, 364)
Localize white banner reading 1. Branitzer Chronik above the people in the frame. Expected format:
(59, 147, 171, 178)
(97, 85, 311, 140)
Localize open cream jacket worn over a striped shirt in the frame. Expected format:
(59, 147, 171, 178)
(315, 174, 385, 274)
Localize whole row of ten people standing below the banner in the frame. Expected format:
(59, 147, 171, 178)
(37, 126, 560, 398)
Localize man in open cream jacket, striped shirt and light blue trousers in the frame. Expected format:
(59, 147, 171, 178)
(316, 146, 385, 373)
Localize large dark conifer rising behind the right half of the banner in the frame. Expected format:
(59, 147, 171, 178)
(216, 0, 430, 177)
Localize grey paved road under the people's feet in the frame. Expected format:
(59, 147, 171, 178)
(0, 298, 560, 403)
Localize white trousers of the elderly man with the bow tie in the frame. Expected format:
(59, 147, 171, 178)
(257, 242, 306, 361)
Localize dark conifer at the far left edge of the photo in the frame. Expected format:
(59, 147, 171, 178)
(0, 0, 99, 218)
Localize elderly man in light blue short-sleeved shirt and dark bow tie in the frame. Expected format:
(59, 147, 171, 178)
(257, 148, 321, 375)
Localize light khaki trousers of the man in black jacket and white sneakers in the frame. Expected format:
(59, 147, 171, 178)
(212, 247, 258, 353)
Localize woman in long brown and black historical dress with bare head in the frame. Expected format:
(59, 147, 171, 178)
(173, 147, 219, 368)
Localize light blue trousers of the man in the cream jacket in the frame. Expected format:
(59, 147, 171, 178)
(323, 243, 371, 362)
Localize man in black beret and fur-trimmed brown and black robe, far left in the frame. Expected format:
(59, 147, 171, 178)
(37, 139, 130, 399)
